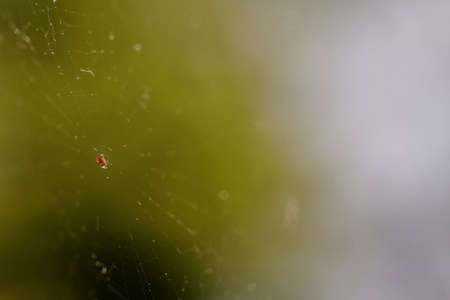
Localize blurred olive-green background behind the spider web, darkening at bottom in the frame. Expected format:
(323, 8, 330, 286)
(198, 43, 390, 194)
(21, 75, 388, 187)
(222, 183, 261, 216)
(0, 0, 314, 299)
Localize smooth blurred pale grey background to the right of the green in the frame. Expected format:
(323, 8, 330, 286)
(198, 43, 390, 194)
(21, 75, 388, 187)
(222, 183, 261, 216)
(238, 1, 450, 300)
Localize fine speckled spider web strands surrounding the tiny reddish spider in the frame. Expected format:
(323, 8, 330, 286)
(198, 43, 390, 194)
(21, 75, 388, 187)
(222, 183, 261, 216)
(2, 1, 306, 299)
